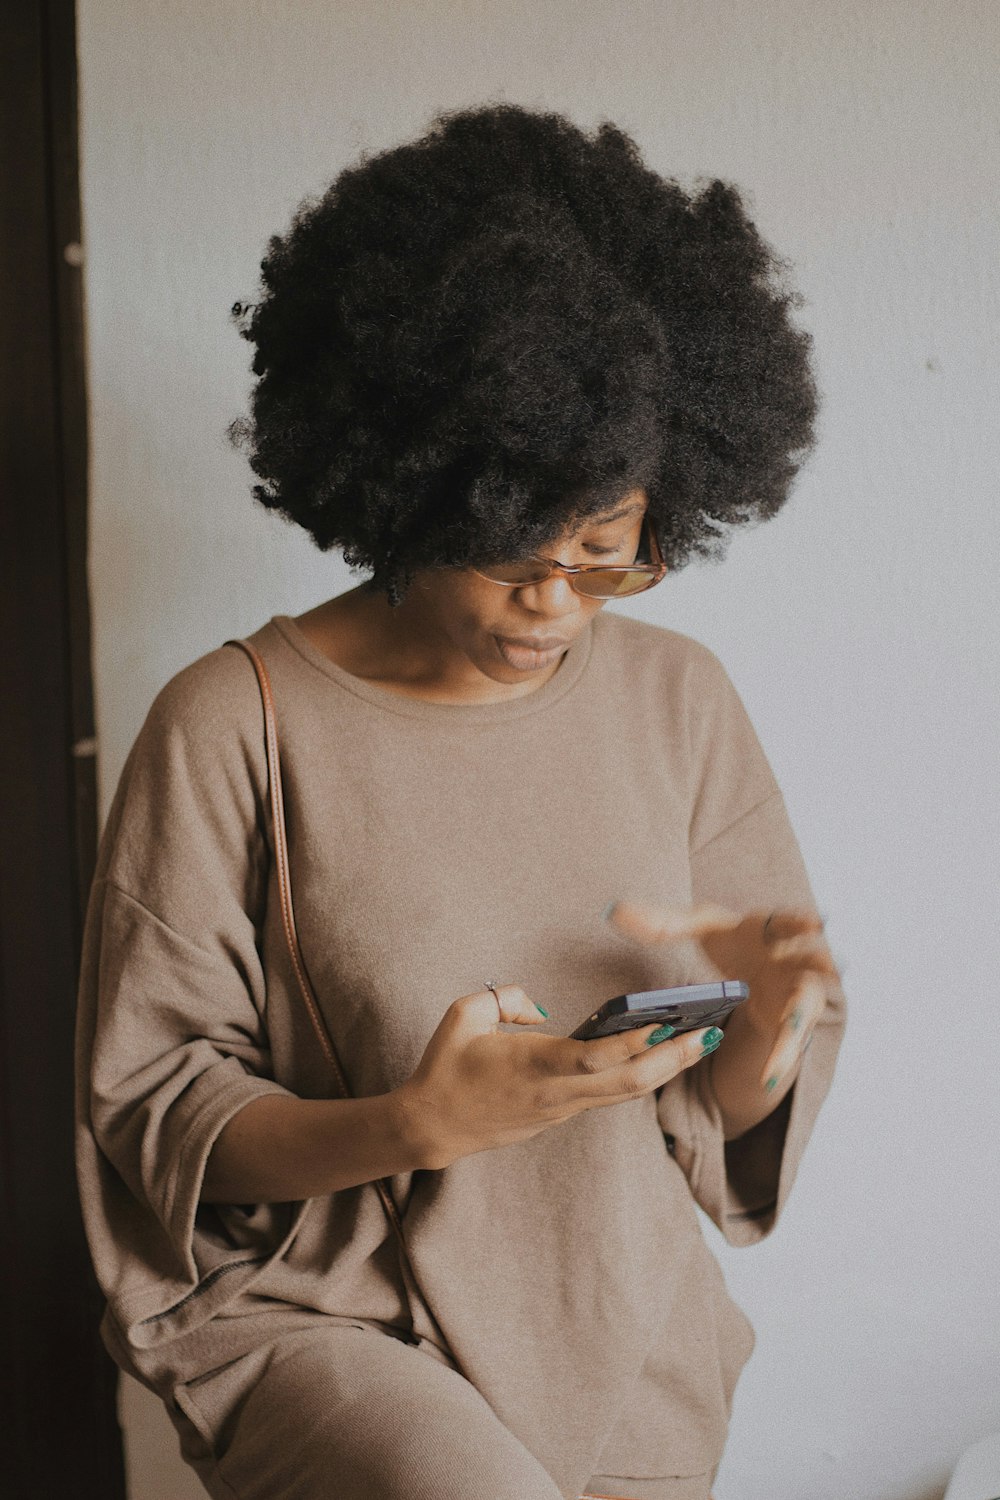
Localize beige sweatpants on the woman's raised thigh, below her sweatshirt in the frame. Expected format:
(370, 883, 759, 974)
(171, 1325, 712, 1500)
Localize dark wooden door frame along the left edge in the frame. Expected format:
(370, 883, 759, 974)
(0, 0, 124, 1500)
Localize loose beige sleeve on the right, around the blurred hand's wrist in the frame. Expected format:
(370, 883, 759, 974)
(657, 653, 846, 1245)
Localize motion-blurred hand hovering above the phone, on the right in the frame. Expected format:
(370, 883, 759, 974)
(607, 902, 838, 1094)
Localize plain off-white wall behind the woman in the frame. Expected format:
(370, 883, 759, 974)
(79, 0, 1000, 1500)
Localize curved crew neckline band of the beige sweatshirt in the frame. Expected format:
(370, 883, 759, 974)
(270, 615, 600, 725)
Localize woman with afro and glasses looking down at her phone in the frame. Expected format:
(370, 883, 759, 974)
(78, 105, 843, 1500)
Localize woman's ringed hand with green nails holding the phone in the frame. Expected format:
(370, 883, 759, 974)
(396, 984, 720, 1170)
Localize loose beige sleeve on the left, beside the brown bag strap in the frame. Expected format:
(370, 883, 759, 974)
(76, 650, 305, 1347)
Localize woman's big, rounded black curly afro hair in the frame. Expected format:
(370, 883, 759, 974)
(228, 102, 817, 603)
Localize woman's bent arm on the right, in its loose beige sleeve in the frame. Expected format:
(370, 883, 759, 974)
(638, 653, 846, 1245)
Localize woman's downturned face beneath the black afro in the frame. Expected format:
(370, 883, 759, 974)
(396, 489, 648, 692)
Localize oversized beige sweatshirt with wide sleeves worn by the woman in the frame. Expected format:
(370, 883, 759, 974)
(78, 612, 843, 1497)
